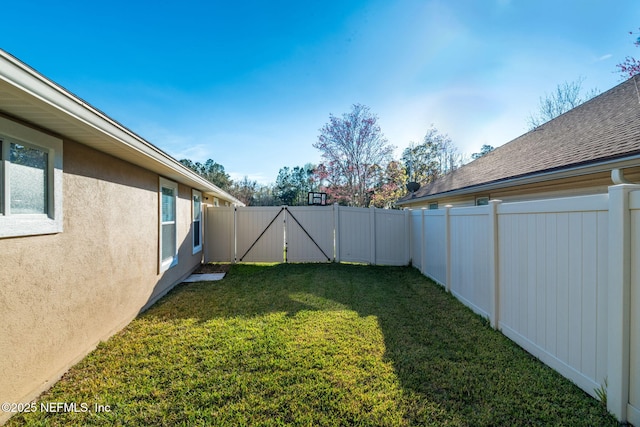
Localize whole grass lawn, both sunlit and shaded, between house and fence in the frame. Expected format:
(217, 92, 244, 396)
(8, 264, 617, 426)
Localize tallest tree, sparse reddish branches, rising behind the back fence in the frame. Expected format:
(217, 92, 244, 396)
(313, 104, 394, 207)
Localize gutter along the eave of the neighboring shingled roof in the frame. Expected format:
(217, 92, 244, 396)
(396, 154, 640, 206)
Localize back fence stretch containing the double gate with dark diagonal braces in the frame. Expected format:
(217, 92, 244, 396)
(205, 205, 410, 265)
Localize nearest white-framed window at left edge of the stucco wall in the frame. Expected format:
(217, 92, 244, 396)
(0, 117, 62, 238)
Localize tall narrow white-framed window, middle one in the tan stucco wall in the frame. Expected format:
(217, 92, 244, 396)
(159, 178, 178, 273)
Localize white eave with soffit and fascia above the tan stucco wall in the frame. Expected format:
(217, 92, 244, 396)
(0, 49, 244, 206)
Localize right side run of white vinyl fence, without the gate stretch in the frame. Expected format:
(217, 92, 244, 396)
(409, 184, 640, 425)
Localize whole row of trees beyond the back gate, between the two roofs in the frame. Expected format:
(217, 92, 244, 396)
(180, 104, 493, 208)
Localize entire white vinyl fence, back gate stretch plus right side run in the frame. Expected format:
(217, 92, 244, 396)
(205, 184, 640, 426)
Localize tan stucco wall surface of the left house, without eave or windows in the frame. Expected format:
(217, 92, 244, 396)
(0, 140, 202, 422)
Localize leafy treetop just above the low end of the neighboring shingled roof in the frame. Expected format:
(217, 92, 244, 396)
(402, 125, 463, 183)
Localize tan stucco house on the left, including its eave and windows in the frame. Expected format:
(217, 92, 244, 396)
(0, 50, 243, 424)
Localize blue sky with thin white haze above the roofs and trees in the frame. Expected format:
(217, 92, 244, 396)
(0, 0, 640, 183)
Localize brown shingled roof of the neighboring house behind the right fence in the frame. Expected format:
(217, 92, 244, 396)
(398, 76, 640, 205)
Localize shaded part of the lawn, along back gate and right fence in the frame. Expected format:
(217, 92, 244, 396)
(142, 264, 617, 425)
